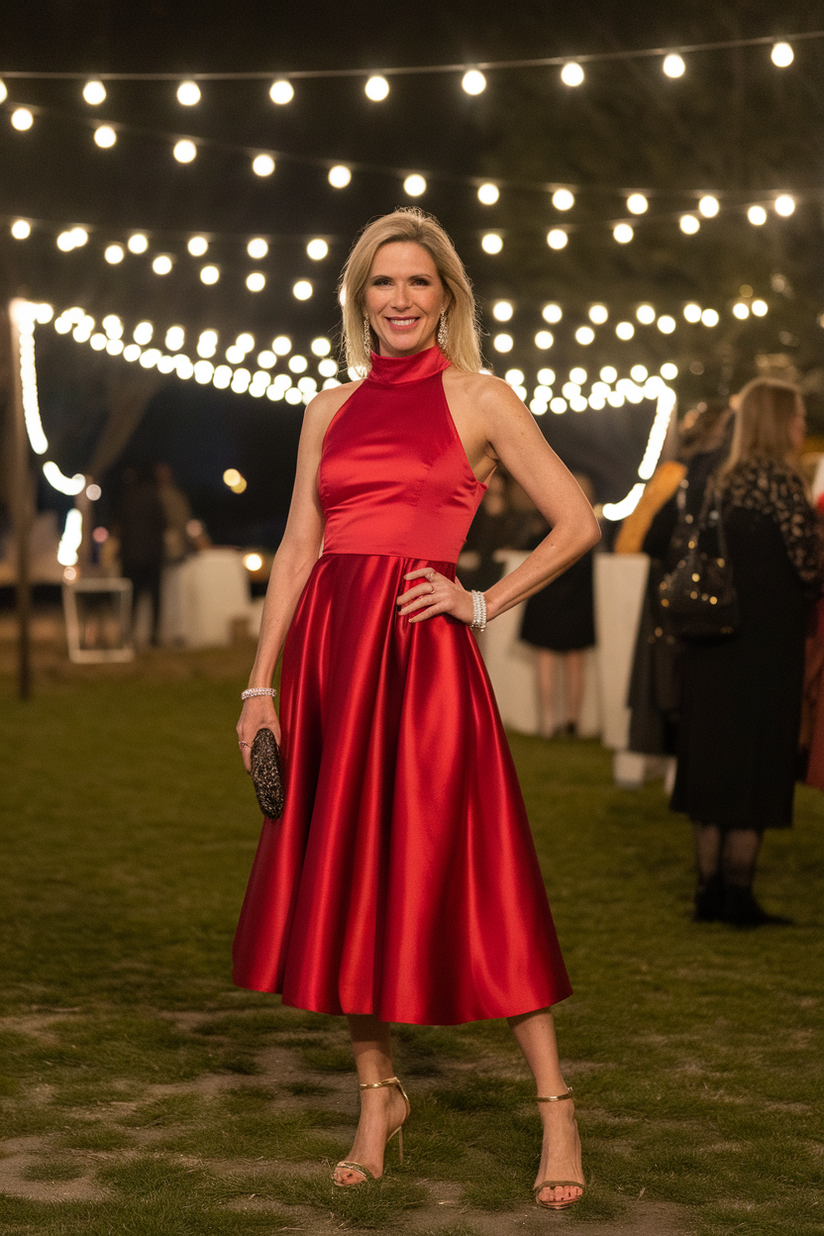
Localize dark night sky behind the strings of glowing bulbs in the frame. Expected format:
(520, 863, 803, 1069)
(0, 0, 824, 544)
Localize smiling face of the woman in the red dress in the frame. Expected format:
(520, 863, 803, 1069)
(363, 241, 448, 356)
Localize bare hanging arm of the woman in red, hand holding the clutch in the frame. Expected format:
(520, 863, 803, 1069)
(237, 383, 355, 771)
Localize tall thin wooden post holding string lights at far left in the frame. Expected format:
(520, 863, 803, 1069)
(9, 300, 33, 700)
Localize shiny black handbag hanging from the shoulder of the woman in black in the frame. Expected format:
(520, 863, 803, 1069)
(658, 488, 741, 639)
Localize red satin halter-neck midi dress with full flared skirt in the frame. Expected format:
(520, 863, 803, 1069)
(233, 347, 571, 1025)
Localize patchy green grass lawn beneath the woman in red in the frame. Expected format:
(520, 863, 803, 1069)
(0, 650, 824, 1236)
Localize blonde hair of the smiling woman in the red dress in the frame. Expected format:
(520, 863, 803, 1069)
(338, 206, 483, 373)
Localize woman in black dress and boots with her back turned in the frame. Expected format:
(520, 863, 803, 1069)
(672, 378, 822, 927)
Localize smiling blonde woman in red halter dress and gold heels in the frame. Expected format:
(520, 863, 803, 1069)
(235, 210, 598, 1209)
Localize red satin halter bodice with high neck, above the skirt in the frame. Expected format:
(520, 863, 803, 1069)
(317, 347, 486, 562)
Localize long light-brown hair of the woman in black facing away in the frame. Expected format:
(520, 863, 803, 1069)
(721, 378, 804, 475)
